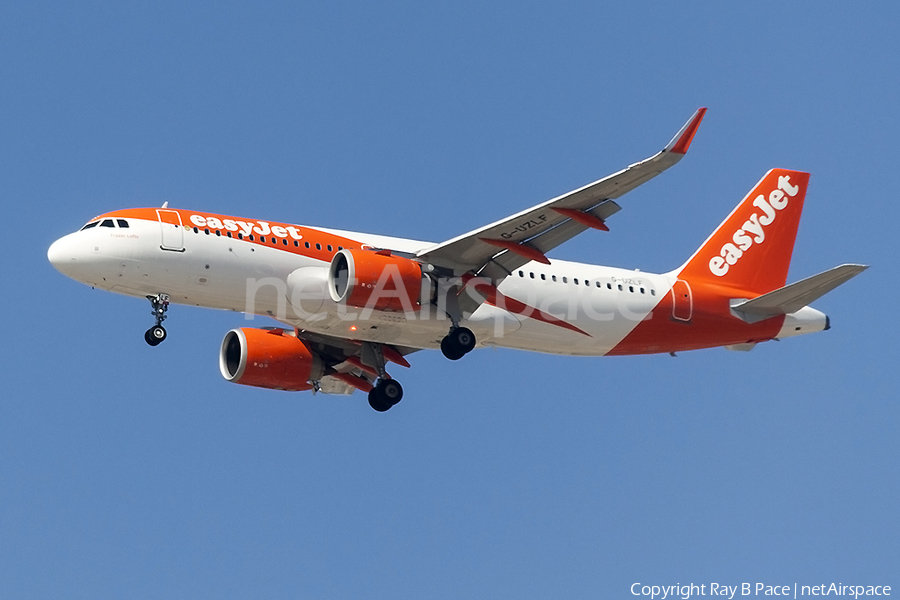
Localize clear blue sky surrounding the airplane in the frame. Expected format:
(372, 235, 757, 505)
(0, 1, 900, 598)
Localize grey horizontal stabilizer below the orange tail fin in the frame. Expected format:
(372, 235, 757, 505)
(731, 265, 869, 323)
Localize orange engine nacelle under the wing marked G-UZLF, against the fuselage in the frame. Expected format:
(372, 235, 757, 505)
(328, 250, 431, 311)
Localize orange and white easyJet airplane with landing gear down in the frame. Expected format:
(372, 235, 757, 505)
(47, 108, 868, 412)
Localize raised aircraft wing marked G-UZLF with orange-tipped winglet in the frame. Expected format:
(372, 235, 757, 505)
(417, 108, 706, 283)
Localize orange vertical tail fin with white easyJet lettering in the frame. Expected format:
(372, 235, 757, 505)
(678, 169, 809, 295)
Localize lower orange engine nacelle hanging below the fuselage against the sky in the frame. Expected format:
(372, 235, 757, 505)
(219, 327, 323, 392)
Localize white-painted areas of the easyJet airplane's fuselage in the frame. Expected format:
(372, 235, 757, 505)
(49, 219, 676, 356)
